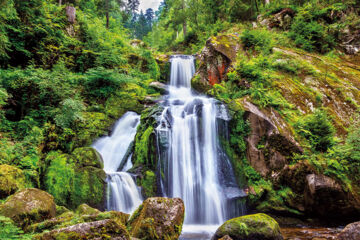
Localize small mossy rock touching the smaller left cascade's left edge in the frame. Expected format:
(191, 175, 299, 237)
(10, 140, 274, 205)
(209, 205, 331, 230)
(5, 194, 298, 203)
(72, 147, 104, 169)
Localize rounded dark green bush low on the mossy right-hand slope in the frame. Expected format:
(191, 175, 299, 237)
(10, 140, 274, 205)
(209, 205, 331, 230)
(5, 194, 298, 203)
(296, 110, 335, 152)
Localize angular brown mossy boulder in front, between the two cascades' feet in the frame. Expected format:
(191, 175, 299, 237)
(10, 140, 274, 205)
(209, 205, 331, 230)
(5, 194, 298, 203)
(129, 198, 185, 240)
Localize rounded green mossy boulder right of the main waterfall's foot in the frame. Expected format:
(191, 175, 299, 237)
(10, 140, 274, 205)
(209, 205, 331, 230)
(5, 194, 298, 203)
(213, 213, 283, 240)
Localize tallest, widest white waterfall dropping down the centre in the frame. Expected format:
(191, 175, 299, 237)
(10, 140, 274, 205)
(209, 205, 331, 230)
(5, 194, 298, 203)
(156, 56, 244, 238)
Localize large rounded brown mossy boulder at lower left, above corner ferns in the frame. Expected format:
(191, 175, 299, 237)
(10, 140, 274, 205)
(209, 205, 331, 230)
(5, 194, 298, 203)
(0, 188, 56, 228)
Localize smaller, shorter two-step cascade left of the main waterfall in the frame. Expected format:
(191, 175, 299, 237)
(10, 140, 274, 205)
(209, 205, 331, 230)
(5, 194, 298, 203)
(93, 112, 143, 213)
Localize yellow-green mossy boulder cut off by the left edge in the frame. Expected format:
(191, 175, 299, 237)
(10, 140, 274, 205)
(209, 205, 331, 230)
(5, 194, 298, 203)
(0, 164, 25, 199)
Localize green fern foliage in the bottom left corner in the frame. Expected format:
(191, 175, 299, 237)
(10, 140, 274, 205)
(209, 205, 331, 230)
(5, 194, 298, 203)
(0, 215, 32, 240)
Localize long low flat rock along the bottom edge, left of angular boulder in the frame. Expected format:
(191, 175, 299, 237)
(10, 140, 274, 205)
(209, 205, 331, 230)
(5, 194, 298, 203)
(37, 219, 130, 240)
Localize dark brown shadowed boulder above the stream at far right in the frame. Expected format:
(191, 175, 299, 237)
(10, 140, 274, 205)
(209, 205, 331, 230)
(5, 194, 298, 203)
(304, 174, 359, 218)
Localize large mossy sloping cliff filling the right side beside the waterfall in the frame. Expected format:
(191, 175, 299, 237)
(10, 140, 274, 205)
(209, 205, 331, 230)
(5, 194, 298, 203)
(192, 31, 360, 221)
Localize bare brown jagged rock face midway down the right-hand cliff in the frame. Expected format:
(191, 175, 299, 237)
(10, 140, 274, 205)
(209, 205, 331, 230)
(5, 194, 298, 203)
(242, 99, 302, 177)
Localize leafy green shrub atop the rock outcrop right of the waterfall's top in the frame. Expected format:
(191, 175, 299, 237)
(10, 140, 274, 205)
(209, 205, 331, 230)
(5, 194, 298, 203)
(241, 29, 273, 54)
